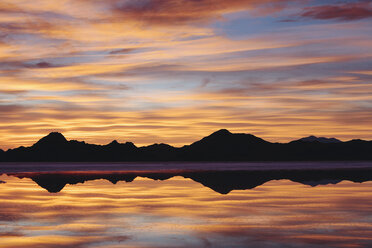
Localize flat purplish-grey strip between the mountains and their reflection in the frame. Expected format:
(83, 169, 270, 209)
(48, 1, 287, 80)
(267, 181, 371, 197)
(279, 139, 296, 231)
(0, 161, 372, 173)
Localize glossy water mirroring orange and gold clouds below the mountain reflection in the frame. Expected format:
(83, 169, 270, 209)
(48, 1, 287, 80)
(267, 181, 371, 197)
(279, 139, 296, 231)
(0, 170, 372, 248)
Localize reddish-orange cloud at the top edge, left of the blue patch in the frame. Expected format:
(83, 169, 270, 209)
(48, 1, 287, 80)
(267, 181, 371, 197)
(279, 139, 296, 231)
(110, 0, 290, 25)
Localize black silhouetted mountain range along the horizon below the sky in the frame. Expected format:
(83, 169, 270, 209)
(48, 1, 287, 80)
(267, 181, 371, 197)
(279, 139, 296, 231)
(0, 129, 372, 162)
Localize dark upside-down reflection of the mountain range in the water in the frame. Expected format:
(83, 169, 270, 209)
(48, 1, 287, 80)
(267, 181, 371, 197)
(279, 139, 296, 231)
(11, 168, 372, 194)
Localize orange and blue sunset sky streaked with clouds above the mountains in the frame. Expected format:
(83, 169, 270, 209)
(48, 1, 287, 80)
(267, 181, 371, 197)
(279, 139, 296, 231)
(0, 0, 372, 149)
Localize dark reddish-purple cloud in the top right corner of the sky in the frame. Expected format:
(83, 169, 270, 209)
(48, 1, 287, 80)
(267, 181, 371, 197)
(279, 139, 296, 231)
(301, 1, 372, 21)
